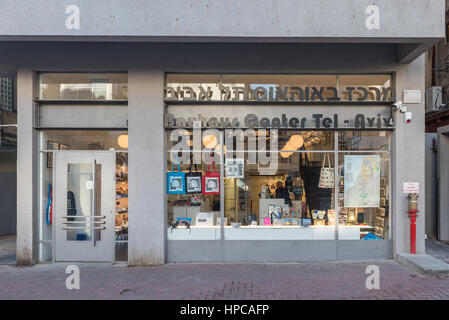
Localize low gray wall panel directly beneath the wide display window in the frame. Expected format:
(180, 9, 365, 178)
(167, 240, 393, 262)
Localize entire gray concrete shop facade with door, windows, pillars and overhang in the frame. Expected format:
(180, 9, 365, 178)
(0, 0, 444, 265)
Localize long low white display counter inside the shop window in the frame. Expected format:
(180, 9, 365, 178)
(167, 226, 365, 240)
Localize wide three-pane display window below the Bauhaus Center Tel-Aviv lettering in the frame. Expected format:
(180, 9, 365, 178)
(166, 129, 390, 240)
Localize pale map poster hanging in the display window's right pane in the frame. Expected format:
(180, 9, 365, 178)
(344, 155, 380, 208)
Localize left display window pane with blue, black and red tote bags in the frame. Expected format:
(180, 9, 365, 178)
(167, 130, 222, 240)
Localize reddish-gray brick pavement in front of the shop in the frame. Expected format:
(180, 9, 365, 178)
(0, 260, 449, 300)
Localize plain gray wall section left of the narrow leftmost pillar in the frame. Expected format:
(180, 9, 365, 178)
(0, 171, 17, 236)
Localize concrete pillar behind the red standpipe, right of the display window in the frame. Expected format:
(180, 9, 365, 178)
(391, 54, 425, 254)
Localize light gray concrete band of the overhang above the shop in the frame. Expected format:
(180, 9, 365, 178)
(0, 0, 445, 42)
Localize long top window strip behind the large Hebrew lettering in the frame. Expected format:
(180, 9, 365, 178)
(165, 74, 394, 102)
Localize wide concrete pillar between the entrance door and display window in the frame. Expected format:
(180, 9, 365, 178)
(128, 70, 167, 265)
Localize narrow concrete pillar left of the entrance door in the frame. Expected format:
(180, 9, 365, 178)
(17, 70, 38, 265)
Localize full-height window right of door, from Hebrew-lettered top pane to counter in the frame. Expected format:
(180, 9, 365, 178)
(164, 74, 394, 240)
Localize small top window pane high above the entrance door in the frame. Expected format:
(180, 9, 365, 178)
(39, 73, 128, 101)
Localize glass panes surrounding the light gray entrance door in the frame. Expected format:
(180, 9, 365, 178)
(39, 130, 128, 261)
